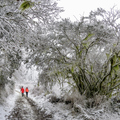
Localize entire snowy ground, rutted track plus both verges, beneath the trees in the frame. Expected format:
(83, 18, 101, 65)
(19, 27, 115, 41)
(0, 83, 120, 120)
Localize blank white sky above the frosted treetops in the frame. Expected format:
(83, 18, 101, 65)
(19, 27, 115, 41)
(58, 0, 120, 20)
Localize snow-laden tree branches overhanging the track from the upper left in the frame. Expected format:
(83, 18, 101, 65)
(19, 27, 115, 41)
(0, 0, 62, 89)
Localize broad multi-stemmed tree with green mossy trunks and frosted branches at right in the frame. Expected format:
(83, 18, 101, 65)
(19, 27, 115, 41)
(26, 9, 119, 97)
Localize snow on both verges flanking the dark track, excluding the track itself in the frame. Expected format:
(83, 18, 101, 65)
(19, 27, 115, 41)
(0, 82, 120, 120)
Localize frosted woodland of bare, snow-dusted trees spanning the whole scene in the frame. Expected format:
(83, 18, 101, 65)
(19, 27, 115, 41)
(0, 0, 120, 119)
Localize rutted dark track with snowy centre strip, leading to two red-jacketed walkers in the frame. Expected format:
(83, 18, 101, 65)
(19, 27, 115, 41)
(6, 97, 52, 120)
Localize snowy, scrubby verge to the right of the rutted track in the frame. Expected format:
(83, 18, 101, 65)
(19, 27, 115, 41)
(31, 84, 120, 120)
